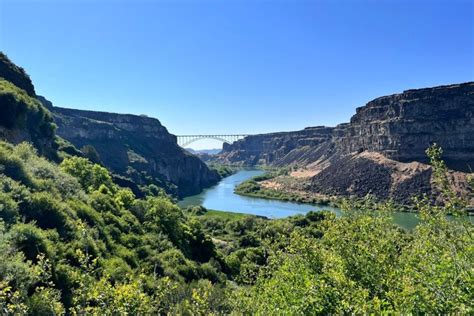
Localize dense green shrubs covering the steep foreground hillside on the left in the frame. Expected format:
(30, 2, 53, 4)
(0, 142, 226, 314)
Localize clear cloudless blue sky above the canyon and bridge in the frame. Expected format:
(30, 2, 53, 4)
(0, 0, 474, 148)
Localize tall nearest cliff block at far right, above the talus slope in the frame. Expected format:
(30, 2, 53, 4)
(333, 82, 474, 171)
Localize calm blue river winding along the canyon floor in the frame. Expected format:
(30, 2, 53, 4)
(178, 169, 418, 229)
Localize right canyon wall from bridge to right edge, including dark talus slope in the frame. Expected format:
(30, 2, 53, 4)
(217, 82, 474, 204)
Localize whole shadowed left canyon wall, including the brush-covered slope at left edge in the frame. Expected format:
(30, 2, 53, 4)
(0, 52, 219, 196)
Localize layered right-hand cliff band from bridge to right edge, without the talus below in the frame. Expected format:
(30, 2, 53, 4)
(219, 82, 474, 171)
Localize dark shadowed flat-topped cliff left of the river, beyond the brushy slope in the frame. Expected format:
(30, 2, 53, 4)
(53, 107, 219, 196)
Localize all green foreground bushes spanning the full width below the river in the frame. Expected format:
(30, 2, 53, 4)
(0, 143, 474, 315)
